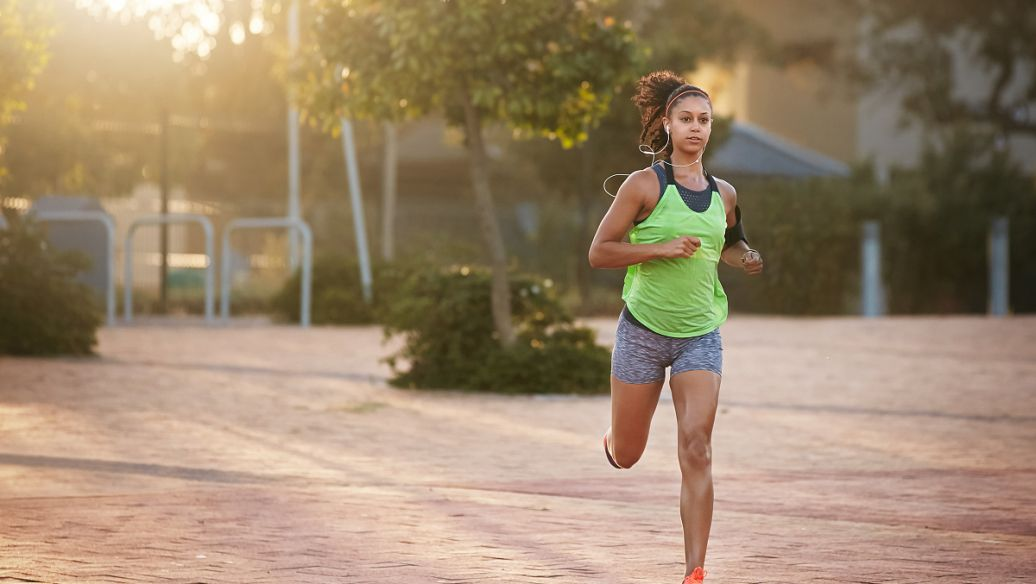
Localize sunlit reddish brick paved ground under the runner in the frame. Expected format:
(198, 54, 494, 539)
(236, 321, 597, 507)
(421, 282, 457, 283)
(0, 317, 1036, 584)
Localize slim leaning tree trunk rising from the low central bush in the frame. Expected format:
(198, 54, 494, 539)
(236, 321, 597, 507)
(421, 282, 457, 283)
(463, 93, 515, 347)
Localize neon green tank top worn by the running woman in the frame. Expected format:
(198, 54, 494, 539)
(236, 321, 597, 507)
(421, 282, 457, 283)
(623, 165, 727, 338)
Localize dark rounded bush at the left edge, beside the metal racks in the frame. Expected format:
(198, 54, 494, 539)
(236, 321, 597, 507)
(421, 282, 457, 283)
(0, 209, 100, 355)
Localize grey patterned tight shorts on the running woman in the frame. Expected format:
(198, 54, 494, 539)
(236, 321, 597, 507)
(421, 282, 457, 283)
(611, 309, 723, 383)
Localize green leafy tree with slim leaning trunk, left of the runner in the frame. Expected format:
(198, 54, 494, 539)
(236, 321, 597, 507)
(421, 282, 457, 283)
(299, 0, 639, 346)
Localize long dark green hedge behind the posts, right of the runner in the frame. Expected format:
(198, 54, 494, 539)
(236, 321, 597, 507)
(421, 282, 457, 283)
(720, 136, 1036, 315)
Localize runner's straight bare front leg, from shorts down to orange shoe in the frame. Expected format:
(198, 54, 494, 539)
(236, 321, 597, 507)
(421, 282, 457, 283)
(669, 370, 721, 575)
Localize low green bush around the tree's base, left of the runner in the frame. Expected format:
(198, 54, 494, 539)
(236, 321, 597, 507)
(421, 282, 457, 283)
(380, 265, 610, 393)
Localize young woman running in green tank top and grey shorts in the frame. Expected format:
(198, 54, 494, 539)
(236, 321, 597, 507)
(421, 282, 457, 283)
(589, 71, 762, 584)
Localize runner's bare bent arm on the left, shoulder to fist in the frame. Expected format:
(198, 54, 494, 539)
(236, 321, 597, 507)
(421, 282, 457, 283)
(589, 169, 701, 268)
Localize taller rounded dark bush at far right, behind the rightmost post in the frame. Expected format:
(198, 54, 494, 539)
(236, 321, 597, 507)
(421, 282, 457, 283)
(870, 134, 1036, 314)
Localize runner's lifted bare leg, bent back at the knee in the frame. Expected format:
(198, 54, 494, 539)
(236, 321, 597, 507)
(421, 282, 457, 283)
(608, 375, 665, 468)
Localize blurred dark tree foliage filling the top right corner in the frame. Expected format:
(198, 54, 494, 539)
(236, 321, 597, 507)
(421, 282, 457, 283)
(854, 0, 1036, 138)
